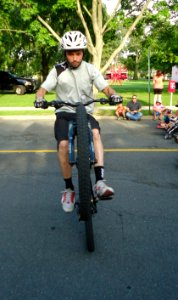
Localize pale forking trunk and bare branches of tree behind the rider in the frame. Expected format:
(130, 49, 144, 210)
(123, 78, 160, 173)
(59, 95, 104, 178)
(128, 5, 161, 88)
(37, 0, 152, 73)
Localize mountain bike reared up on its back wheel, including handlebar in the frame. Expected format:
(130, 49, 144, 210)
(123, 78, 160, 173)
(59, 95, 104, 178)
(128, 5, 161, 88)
(35, 97, 123, 252)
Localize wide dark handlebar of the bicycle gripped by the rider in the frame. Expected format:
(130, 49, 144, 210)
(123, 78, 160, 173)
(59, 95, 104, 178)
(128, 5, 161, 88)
(34, 97, 123, 109)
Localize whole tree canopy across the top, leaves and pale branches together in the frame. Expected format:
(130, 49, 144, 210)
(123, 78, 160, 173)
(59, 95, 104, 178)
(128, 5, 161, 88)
(0, 0, 178, 77)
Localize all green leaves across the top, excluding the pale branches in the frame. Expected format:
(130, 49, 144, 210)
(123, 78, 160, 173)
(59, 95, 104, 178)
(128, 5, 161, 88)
(0, 0, 178, 77)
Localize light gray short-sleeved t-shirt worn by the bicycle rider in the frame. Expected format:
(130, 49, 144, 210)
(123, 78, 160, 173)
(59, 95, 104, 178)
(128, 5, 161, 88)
(41, 61, 108, 114)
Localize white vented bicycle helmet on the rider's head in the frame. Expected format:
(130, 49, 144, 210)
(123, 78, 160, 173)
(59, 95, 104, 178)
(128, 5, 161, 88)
(61, 31, 87, 50)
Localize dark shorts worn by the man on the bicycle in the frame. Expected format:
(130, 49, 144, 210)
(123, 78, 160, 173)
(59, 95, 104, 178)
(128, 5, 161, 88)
(54, 112, 100, 144)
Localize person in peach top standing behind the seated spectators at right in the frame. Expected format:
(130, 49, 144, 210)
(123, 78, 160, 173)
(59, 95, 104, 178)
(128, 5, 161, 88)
(153, 70, 164, 104)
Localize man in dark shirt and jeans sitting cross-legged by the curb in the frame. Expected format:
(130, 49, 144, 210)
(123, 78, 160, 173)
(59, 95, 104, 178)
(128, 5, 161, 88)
(126, 95, 142, 121)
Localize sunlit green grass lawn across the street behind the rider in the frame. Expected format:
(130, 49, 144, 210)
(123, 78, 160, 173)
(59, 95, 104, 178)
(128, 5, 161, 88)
(0, 80, 178, 116)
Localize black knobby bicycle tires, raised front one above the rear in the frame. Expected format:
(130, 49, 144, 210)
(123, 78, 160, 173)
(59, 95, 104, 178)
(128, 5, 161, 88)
(76, 103, 95, 252)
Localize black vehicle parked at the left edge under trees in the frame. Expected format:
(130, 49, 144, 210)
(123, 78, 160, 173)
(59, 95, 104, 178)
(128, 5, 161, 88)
(0, 71, 38, 95)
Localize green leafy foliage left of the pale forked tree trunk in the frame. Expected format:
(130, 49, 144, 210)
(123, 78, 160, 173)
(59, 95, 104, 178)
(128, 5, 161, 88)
(0, 0, 81, 77)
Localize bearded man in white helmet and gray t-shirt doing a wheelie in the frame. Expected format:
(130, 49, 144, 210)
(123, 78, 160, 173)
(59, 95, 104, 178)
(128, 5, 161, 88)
(36, 31, 120, 212)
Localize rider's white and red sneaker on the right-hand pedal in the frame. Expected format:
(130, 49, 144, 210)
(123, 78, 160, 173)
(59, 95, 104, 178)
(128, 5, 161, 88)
(93, 180, 114, 199)
